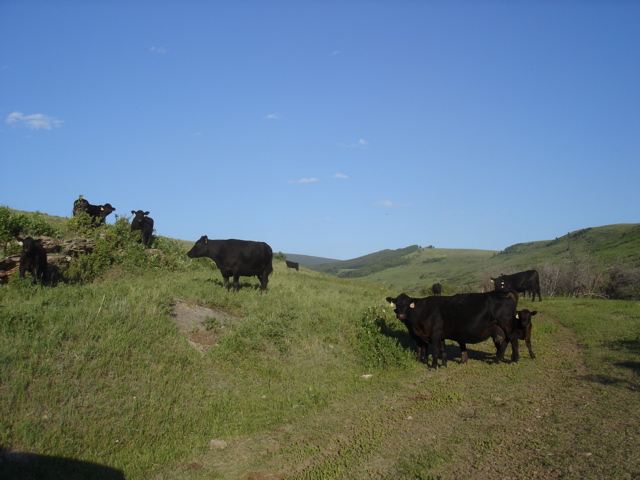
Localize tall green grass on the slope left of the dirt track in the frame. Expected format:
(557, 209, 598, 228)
(0, 262, 410, 479)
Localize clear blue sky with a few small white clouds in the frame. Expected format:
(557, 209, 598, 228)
(0, 0, 640, 259)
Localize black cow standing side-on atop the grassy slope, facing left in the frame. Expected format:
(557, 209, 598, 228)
(187, 235, 273, 291)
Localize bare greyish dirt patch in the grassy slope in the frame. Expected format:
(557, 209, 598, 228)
(171, 298, 238, 354)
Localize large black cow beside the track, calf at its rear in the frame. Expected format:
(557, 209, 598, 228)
(384, 291, 517, 368)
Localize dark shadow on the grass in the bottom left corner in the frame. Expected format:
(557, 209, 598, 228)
(0, 447, 125, 480)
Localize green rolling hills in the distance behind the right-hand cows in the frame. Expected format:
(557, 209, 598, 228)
(310, 223, 640, 294)
